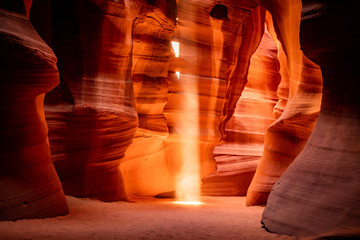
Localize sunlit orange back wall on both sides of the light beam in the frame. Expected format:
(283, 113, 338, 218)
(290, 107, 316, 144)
(121, 1, 260, 199)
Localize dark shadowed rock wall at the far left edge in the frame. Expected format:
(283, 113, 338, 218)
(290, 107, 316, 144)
(0, 1, 68, 220)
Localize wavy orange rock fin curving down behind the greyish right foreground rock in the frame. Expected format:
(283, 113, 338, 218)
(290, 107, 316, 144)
(247, 0, 322, 206)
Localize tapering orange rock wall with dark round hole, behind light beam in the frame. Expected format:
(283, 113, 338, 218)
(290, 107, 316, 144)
(164, 1, 263, 201)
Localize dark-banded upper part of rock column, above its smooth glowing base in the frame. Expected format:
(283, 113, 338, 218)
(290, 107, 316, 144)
(132, 3, 176, 133)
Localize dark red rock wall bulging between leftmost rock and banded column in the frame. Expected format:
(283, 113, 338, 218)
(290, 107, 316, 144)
(31, 0, 137, 201)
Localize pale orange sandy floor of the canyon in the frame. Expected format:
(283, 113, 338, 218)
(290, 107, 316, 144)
(0, 196, 295, 240)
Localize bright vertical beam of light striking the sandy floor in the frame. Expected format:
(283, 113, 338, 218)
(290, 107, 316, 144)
(171, 41, 201, 205)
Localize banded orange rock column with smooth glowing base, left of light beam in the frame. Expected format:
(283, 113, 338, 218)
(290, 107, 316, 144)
(121, 1, 176, 196)
